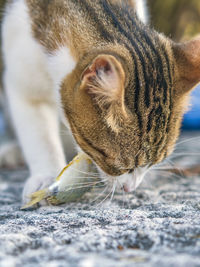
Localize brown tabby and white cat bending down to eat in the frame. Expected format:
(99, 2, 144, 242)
(2, 0, 200, 205)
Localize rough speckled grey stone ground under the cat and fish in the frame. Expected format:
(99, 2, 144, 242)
(0, 134, 200, 267)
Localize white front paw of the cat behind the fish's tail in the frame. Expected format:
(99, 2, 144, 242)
(22, 175, 55, 205)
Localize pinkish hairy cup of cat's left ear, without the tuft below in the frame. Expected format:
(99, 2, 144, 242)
(82, 55, 125, 106)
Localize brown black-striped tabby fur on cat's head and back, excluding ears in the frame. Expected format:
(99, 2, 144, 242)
(6, 0, 200, 178)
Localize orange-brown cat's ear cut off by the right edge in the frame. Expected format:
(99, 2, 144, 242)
(173, 37, 200, 94)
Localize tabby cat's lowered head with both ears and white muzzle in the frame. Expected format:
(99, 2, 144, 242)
(61, 35, 200, 191)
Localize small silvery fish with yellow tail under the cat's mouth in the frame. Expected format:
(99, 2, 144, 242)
(21, 153, 100, 209)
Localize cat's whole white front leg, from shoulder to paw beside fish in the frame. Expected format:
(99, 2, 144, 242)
(2, 1, 65, 202)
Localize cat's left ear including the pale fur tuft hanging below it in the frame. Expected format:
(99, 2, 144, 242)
(81, 54, 126, 133)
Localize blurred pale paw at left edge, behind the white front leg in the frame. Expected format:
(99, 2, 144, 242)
(0, 141, 25, 169)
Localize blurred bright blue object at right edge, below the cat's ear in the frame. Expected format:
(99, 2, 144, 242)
(182, 85, 200, 130)
